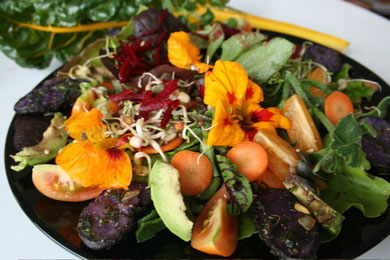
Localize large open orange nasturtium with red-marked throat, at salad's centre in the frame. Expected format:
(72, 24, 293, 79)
(204, 61, 291, 146)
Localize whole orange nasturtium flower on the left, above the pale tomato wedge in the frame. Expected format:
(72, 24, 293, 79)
(56, 108, 132, 189)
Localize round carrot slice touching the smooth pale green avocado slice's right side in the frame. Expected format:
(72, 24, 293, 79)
(171, 150, 213, 196)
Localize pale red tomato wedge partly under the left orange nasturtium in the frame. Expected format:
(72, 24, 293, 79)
(32, 164, 103, 202)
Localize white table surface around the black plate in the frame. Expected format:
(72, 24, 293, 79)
(0, 0, 390, 259)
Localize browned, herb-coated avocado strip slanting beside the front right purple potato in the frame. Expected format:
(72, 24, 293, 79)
(283, 174, 345, 236)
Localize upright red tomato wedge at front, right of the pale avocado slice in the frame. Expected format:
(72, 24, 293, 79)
(191, 185, 238, 257)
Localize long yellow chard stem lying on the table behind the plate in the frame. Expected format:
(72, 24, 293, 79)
(196, 7, 349, 52)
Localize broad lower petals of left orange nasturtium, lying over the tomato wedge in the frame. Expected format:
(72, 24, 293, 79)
(56, 138, 132, 189)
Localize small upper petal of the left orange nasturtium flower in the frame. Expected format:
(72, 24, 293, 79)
(64, 108, 104, 141)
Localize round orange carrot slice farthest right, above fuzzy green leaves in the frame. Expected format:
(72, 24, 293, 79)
(325, 91, 353, 125)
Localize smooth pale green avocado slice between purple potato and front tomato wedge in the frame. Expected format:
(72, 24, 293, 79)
(149, 160, 193, 241)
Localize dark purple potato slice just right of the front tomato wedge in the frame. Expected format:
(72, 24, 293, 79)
(251, 189, 320, 258)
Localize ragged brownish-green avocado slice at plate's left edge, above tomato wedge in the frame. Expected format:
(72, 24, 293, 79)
(11, 113, 68, 171)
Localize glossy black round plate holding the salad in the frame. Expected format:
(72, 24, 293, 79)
(5, 32, 390, 259)
